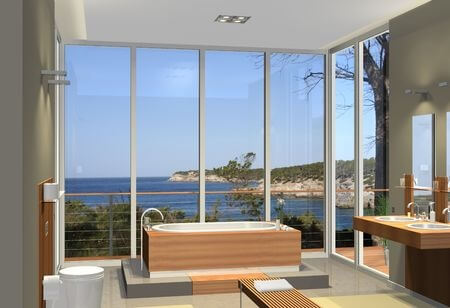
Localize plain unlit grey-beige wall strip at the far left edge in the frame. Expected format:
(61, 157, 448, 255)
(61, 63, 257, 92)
(0, 0, 23, 307)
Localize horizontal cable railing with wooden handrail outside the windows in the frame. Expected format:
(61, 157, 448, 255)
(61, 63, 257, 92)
(65, 189, 388, 260)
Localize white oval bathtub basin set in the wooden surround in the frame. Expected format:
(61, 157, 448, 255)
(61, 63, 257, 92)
(152, 221, 275, 232)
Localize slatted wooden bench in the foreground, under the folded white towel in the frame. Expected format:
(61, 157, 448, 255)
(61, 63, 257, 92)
(239, 277, 320, 308)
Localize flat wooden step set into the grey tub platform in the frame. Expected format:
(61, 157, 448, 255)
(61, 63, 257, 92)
(190, 273, 267, 295)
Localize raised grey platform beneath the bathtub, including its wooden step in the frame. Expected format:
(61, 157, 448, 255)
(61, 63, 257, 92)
(122, 259, 329, 298)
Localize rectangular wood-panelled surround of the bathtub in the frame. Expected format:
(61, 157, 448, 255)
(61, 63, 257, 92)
(143, 230, 301, 272)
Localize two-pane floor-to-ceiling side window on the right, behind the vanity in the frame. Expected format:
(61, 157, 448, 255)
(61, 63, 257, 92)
(330, 32, 390, 274)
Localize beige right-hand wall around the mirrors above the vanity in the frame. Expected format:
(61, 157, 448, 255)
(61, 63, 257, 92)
(389, 0, 450, 284)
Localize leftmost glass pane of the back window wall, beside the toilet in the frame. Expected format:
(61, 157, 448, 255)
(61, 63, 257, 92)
(65, 46, 130, 260)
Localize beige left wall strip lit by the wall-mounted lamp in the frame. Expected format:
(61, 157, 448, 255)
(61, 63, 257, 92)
(23, 0, 55, 307)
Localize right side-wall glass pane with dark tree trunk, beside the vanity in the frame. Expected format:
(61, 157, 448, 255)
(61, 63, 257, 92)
(362, 33, 389, 274)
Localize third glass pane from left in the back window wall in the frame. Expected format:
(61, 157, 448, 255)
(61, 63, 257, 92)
(205, 51, 264, 221)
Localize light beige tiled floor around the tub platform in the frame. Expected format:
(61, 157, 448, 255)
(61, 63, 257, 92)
(102, 259, 426, 308)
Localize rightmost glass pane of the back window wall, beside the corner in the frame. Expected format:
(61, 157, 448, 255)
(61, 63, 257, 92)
(270, 53, 325, 251)
